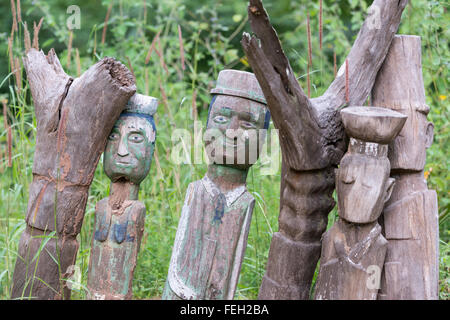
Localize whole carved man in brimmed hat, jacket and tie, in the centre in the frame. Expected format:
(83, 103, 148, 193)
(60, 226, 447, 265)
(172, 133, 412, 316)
(163, 70, 270, 300)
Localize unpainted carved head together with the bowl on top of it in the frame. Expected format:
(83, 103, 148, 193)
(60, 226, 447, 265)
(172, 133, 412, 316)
(336, 107, 406, 223)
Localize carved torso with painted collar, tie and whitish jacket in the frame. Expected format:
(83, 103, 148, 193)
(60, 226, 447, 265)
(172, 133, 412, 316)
(163, 176, 254, 299)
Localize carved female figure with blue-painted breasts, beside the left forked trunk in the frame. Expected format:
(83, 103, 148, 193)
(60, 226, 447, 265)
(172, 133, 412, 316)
(88, 94, 158, 300)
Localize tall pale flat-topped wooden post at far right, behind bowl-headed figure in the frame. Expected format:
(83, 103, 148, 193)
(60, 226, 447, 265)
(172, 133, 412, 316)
(372, 35, 439, 300)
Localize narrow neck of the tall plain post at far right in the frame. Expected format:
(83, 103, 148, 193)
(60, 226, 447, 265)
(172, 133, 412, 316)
(387, 171, 428, 205)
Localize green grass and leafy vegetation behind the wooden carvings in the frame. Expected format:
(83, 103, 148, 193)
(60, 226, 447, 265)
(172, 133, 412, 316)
(0, 0, 450, 299)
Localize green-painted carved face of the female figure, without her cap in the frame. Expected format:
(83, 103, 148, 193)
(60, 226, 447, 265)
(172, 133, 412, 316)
(104, 115, 155, 184)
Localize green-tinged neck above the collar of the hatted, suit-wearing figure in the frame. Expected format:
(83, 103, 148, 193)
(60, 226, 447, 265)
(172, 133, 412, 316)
(206, 164, 248, 193)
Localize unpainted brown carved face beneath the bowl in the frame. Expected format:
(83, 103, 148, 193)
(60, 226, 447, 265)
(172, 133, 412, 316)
(336, 154, 394, 223)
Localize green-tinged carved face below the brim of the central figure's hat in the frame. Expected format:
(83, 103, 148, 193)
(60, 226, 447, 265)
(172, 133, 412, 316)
(204, 95, 267, 169)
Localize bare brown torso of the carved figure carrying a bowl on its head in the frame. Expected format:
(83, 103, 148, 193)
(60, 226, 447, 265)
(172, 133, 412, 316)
(316, 219, 387, 300)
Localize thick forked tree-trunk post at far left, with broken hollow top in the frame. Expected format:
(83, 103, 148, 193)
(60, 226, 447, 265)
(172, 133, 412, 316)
(11, 49, 136, 299)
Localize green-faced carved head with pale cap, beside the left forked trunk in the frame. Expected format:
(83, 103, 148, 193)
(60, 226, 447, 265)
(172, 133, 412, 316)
(104, 94, 158, 184)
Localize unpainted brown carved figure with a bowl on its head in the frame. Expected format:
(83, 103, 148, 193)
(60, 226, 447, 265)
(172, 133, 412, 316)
(315, 107, 406, 300)
